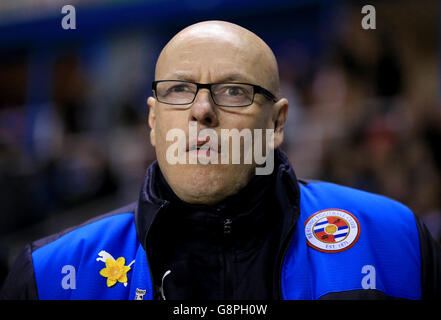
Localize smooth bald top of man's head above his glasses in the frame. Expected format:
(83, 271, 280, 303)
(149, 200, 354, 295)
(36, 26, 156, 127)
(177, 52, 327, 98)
(155, 21, 279, 97)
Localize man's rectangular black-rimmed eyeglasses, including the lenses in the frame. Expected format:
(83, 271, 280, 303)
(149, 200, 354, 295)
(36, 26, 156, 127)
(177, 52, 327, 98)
(152, 80, 277, 107)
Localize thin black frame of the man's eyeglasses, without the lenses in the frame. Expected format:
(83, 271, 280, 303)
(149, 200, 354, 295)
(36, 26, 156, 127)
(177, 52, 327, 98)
(152, 80, 277, 108)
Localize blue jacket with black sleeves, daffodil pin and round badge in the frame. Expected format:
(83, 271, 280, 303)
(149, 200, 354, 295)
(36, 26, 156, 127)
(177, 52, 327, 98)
(1, 151, 441, 300)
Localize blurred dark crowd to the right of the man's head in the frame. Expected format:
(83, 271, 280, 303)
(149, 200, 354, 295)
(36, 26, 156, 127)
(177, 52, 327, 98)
(281, 5, 441, 242)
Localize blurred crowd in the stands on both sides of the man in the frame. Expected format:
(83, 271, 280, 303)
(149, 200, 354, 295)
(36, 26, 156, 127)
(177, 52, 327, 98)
(0, 3, 441, 288)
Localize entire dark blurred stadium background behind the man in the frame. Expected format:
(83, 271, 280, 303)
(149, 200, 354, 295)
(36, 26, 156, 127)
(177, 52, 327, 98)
(0, 0, 441, 286)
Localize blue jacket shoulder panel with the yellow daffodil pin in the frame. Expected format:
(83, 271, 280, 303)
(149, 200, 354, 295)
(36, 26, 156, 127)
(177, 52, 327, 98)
(32, 213, 152, 300)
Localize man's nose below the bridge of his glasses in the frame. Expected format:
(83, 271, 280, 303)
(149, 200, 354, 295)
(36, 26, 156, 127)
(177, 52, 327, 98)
(189, 89, 219, 127)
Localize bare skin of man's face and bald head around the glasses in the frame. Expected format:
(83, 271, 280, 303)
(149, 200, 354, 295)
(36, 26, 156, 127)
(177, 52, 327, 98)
(148, 24, 286, 204)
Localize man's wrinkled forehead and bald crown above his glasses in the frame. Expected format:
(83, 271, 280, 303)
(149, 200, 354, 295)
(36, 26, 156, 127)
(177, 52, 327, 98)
(155, 25, 278, 94)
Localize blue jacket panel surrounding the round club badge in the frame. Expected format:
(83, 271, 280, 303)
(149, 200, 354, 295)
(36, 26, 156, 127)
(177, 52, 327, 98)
(281, 182, 421, 299)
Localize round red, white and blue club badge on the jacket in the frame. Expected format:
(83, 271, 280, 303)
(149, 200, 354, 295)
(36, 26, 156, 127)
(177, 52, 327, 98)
(305, 209, 360, 252)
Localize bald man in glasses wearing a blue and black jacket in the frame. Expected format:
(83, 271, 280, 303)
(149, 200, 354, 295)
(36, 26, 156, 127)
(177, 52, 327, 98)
(1, 21, 441, 300)
